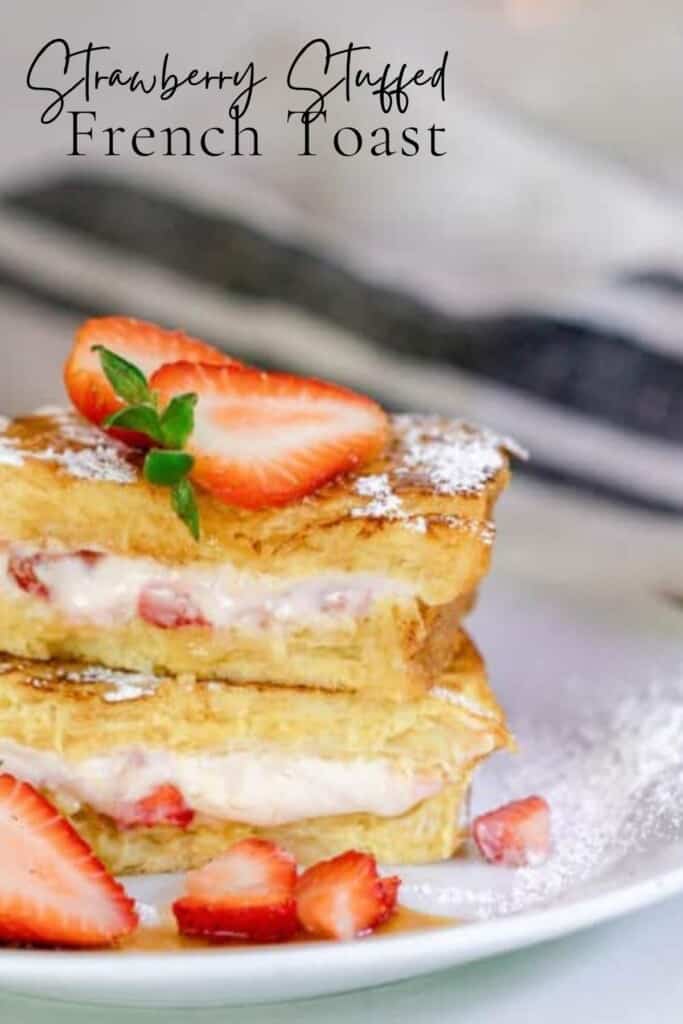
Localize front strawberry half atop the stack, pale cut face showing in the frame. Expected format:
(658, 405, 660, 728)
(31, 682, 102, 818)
(151, 362, 387, 509)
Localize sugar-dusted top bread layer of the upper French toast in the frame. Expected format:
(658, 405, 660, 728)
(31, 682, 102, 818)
(0, 414, 508, 604)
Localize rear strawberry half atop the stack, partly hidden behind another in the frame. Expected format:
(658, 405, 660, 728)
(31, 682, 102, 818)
(65, 316, 240, 446)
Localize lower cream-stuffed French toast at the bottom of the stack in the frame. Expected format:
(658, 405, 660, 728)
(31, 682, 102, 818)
(0, 635, 512, 872)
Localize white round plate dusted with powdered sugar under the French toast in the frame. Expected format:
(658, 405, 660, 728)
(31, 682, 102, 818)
(0, 579, 683, 1007)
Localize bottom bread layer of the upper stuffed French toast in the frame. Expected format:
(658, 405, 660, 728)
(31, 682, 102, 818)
(0, 591, 472, 700)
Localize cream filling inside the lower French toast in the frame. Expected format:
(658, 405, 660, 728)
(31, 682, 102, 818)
(0, 739, 445, 825)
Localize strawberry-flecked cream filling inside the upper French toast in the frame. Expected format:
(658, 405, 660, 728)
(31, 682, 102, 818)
(0, 543, 414, 630)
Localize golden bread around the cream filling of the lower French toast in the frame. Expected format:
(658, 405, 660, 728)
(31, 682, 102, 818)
(0, 634, 513, 873)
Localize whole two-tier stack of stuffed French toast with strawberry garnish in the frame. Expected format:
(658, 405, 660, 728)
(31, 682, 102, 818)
(0, 317, 512, 873)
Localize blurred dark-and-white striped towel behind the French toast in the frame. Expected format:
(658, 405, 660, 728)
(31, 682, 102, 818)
(0, 167, 683, 516)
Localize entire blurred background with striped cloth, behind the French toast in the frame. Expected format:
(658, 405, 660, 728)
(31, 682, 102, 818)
(0, 0, 683, 598)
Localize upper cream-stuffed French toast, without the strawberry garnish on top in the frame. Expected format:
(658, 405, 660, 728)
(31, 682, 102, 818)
(0, 411, 509, 699)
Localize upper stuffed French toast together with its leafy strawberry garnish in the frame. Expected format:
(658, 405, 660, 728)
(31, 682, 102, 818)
(0, 318, 508, 699)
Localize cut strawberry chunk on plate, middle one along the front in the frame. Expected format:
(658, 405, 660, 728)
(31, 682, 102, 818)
(173, 839, 297, 942)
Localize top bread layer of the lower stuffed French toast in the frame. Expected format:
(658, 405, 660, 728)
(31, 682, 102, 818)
(0, 634, 510, 773)
